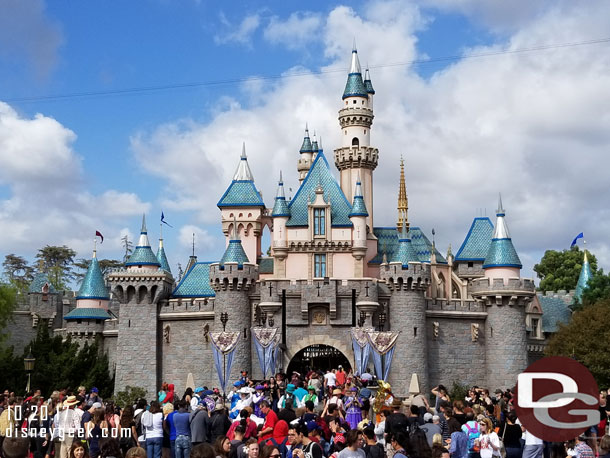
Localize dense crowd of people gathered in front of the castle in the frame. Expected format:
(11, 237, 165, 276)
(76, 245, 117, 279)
(0, 366, 610, 458)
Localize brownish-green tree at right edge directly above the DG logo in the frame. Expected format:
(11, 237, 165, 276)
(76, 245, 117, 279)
(546, 300, 610, 387)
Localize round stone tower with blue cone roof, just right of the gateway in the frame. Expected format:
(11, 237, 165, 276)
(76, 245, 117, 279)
(380, 220, 430, 396)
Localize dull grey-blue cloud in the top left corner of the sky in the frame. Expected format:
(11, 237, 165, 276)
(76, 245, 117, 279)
(0, 0, 63, 78)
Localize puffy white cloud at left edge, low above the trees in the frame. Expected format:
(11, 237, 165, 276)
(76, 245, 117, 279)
(0, 102, 150, 258)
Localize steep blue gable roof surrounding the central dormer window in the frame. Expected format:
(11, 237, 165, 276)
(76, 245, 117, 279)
(286, 150, 352, 227)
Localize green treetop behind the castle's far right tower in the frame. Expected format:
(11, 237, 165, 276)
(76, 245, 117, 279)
(534, 246, 597, 292)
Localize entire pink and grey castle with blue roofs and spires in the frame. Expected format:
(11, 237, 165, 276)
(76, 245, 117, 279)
(12, 45, 580, 395)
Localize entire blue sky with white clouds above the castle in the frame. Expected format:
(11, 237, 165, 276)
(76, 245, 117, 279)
(0, 0, 610, 276)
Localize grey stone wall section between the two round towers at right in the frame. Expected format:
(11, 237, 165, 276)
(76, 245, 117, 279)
(426, 312, 487, 388)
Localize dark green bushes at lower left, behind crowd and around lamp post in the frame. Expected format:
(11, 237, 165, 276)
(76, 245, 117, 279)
(0, 320, 113, 398)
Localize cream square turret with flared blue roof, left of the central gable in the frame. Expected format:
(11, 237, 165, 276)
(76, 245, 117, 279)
(218, 143, 265, 263)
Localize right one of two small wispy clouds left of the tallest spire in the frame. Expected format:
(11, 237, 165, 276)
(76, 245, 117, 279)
(264, 11, 322, 49)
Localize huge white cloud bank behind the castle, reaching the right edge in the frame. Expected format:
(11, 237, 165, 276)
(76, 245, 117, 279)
(132, 1, 610, 275)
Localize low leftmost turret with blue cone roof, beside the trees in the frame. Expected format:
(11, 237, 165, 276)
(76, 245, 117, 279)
(64, 250, 110, 340)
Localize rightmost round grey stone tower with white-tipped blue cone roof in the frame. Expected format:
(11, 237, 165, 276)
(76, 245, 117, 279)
(470, 197, 535, 388)
